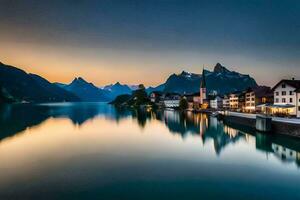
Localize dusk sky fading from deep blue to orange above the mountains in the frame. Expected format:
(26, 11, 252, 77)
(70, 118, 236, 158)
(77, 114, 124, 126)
(0, 0, 300, 86)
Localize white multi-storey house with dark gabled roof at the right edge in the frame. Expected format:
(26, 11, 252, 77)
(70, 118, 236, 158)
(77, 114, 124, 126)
(270, 79, 300, 117)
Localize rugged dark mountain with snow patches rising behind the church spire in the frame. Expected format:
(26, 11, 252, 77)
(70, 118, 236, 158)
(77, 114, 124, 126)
(163, 63, 257, 94)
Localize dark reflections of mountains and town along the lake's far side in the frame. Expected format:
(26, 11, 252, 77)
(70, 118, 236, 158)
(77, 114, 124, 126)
(0, 103, 300, 167)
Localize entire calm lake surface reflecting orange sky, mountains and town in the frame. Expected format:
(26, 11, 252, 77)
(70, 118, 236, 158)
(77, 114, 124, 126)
(0, 103, 300, 199)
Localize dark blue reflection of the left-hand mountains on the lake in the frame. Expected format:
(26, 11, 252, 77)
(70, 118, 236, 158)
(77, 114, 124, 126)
(0, 103, 131, 140)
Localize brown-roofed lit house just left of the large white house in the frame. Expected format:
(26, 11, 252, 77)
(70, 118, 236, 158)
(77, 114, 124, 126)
(245, 86, 273, 112)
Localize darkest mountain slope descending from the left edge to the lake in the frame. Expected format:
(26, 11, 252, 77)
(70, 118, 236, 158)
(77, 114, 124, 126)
(0, 62, 79, 102)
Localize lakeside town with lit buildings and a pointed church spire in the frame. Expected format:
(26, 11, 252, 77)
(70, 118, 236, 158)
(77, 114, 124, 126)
(149, 70, 300, 118)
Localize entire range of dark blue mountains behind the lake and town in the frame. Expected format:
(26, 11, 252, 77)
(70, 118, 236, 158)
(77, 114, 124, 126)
(0, 62, 257, 102)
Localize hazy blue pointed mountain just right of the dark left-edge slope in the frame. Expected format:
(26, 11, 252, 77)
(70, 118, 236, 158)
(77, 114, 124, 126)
(56, 77, 111, 102)
